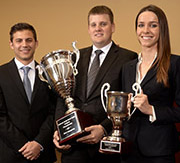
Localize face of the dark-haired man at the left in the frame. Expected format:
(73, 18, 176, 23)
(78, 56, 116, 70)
(10, 30, 38, 64)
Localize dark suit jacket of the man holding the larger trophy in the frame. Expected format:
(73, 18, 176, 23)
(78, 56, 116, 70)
(56, 42, 137, 162)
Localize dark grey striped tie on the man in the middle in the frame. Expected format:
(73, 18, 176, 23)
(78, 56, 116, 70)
(87, 50, 103, 97)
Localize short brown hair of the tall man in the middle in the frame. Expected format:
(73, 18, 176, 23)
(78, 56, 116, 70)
(88, 5, 114, 24)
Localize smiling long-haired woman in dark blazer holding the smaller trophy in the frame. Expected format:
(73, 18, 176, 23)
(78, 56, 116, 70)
(122, 5, 180, 163)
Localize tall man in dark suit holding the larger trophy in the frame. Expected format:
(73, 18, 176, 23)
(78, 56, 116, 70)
(54, 6, 136, 163)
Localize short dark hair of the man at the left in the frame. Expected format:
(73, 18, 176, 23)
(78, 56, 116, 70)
(9, 23, 37, 42)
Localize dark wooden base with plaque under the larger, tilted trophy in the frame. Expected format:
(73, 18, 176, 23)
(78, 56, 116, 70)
(56, 110, 93, 144)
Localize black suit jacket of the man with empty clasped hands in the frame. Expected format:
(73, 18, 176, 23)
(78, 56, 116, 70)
(0, 60, 56, 163)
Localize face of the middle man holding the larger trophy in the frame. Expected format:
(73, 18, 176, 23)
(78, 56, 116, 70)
(88, 14, 115, 48)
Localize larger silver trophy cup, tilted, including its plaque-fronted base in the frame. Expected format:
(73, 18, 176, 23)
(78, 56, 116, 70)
(37, 42, 92, 144)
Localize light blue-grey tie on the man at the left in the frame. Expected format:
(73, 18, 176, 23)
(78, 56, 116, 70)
(22, 67, 32, 103)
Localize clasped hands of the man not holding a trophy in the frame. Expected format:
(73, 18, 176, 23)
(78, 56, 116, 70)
(19, 141, 41, 160)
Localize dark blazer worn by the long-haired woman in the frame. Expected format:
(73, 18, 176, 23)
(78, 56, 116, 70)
(122, 55, 180, 156)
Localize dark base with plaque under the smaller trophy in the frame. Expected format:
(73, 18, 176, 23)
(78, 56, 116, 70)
(100, 140, 132, 154)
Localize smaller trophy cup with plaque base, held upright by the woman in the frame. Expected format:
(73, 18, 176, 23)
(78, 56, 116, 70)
(100, 83, 129, 153)
